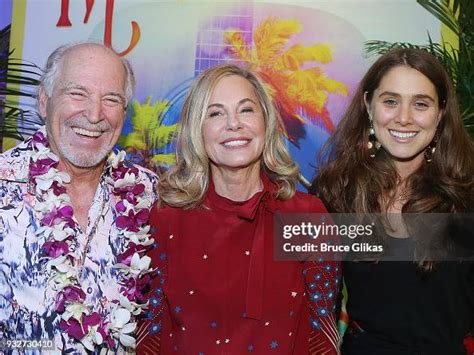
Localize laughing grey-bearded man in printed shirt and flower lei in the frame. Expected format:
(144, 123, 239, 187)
(0, 43, 156, 353)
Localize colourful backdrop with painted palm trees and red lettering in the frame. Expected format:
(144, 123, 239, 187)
(0, 0, 440, 188)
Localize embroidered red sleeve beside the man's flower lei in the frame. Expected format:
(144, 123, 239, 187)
(137, 213, 167, 355)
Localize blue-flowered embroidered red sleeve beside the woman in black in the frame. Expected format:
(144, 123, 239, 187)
(303, 260, 341, 355)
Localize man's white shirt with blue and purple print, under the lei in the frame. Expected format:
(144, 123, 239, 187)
(0, 129, 157, 354)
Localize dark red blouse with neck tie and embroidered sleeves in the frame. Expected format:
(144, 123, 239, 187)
(137, 178, 340, 355)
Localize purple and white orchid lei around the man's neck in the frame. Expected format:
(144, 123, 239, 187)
(29, 130, 153, 351)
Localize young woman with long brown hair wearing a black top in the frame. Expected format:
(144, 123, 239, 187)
(313, 48, 474, 355)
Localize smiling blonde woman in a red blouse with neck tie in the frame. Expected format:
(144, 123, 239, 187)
(138, 65, 339, 355)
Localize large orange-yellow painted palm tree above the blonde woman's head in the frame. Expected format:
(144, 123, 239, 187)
(224, 17, 348, 146)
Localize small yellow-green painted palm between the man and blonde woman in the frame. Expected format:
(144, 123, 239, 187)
(118, 97, 177, 171)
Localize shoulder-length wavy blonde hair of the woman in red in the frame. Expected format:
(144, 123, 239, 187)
(158, 64, 299, 208)
